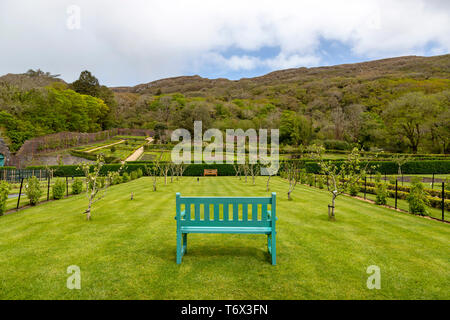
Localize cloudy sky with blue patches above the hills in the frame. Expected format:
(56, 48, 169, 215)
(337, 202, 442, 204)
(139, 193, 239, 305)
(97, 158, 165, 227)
(0, 0, 450, 86)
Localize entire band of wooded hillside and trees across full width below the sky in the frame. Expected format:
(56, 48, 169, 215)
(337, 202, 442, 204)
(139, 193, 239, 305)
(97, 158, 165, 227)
(0, 55, 450, 153)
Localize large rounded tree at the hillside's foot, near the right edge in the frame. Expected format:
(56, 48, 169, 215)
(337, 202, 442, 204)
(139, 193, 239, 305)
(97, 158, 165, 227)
(384, 92, 437, 153)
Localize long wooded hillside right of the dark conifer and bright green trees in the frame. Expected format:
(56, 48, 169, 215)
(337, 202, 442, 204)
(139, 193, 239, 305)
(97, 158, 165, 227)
(113, 55, 450, 153)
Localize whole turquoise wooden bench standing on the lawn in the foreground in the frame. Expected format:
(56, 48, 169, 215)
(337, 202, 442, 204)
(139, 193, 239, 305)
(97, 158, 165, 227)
(175, 192, 277, 265)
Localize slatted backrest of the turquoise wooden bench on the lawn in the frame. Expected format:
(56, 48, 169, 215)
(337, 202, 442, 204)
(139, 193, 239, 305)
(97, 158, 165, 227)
(176, 192, 276, 227)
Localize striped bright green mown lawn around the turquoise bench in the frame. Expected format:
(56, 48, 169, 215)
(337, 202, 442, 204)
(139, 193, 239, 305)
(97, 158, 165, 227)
(0, 177, 450, 299)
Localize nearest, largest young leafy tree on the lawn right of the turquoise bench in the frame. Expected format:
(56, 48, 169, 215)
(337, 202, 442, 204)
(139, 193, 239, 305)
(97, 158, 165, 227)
(311, 145, 369, 221)
